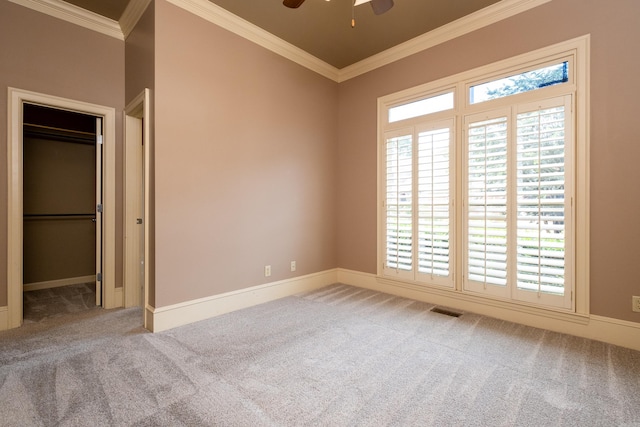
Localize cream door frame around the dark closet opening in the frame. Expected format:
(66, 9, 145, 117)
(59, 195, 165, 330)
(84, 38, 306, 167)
(6, 87, 117, 329)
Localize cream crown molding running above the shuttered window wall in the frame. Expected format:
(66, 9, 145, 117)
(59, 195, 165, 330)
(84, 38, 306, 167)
(338, 0, 551, 83)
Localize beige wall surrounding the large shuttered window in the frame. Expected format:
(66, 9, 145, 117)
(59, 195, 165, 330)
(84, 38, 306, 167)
(338, 0, 640, 322)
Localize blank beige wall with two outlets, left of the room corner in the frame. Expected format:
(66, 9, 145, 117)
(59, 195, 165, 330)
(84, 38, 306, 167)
(155, 0, 338, 307)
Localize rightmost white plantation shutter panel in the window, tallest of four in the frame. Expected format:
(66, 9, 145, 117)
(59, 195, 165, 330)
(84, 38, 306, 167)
(515, 97, 572, 306)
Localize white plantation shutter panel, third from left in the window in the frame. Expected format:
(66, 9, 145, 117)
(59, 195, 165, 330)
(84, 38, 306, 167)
(466, 116, 508, 293)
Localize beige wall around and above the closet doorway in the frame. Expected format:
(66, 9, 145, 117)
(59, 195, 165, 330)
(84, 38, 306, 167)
(0, 1, 124, 306)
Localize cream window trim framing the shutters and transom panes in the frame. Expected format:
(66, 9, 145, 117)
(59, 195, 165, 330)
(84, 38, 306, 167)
(377, 35, 590, 316)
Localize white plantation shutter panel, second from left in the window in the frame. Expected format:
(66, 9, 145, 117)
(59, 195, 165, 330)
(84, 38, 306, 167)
(417, 121, 453, 286)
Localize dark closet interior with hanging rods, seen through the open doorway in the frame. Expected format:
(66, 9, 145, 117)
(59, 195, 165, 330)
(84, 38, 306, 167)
(22, 103, 102, 322)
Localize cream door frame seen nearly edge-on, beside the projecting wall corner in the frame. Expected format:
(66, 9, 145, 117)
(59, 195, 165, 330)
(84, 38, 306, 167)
(124, 89, 153, 329)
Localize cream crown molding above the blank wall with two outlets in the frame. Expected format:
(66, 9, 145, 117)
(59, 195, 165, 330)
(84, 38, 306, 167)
(166, 0, 339, 82)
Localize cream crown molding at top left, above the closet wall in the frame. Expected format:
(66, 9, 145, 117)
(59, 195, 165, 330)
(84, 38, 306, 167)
(9, 0, 123, 40)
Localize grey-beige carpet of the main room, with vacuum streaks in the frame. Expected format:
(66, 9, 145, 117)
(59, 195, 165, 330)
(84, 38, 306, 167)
(0, 284, 640, 427)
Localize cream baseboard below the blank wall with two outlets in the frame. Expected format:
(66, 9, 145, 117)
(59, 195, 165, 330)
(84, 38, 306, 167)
(150, 269, 337, 332)
